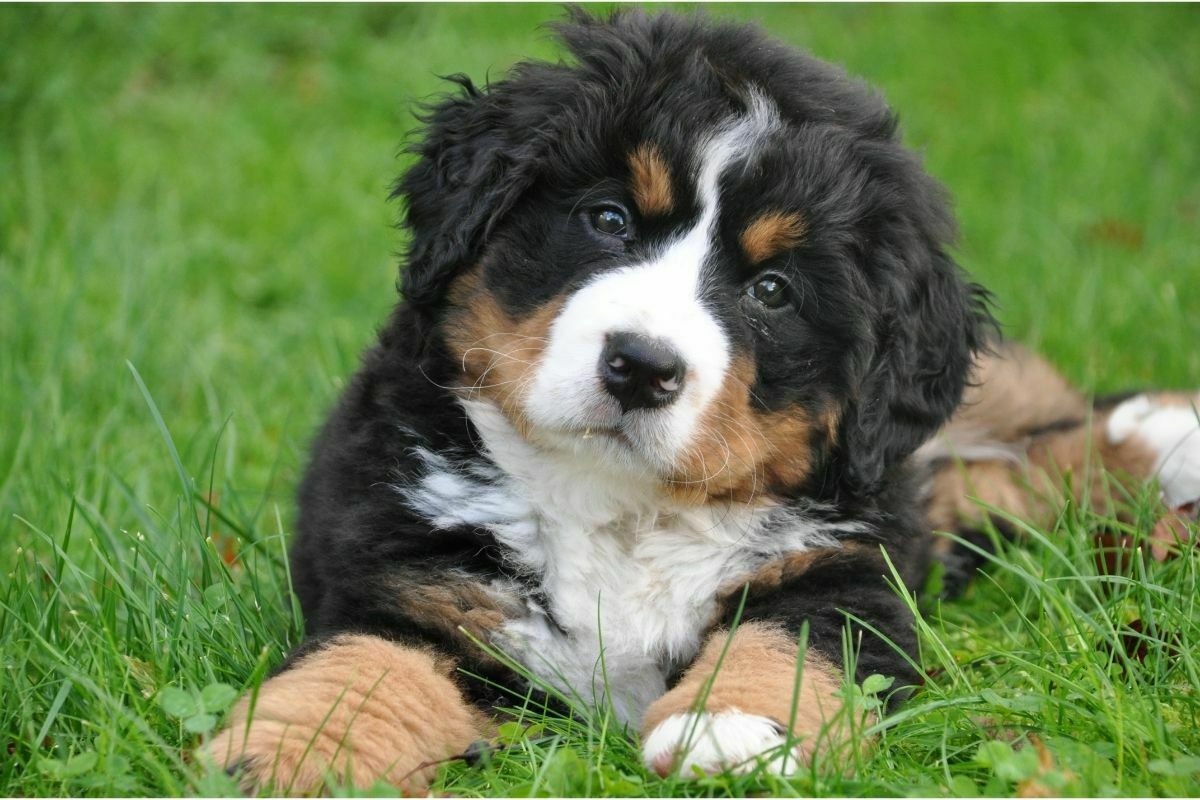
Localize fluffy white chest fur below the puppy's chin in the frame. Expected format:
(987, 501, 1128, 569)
(397, 402, 848, 723)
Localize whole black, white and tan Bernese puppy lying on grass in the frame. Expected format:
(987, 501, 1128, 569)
(208, 11, 1200, 793)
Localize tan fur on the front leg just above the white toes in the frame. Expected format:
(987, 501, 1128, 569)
(642, 622, 848, 758)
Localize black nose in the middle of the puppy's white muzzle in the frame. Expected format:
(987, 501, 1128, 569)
(600, 333, 686, 411)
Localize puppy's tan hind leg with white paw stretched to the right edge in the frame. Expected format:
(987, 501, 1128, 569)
(918, 345, 1200, 595)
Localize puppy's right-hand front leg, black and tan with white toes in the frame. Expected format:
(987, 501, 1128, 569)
(642, 547, 917, 777)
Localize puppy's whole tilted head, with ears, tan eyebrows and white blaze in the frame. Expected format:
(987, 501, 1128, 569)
(397, 7, 986, 501)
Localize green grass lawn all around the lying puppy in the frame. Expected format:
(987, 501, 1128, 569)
(0, 5, 1200, 795)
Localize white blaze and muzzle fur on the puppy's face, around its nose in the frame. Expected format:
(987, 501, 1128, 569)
(524, 94, 779, 470)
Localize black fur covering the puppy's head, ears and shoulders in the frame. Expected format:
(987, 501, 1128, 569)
(293, 4, 990, 719)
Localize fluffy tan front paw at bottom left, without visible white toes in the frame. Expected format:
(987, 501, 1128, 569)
(205, 636, 488, 795)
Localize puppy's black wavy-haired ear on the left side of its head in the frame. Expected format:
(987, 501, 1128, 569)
(392, 74, 538, 306)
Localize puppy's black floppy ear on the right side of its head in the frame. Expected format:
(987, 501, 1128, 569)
(841, 157, 995, 493)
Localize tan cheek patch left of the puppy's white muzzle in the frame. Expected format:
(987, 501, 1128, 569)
(446, 271, 563, 433)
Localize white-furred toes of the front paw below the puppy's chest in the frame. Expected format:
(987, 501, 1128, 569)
(642, 710, 803, 777)
